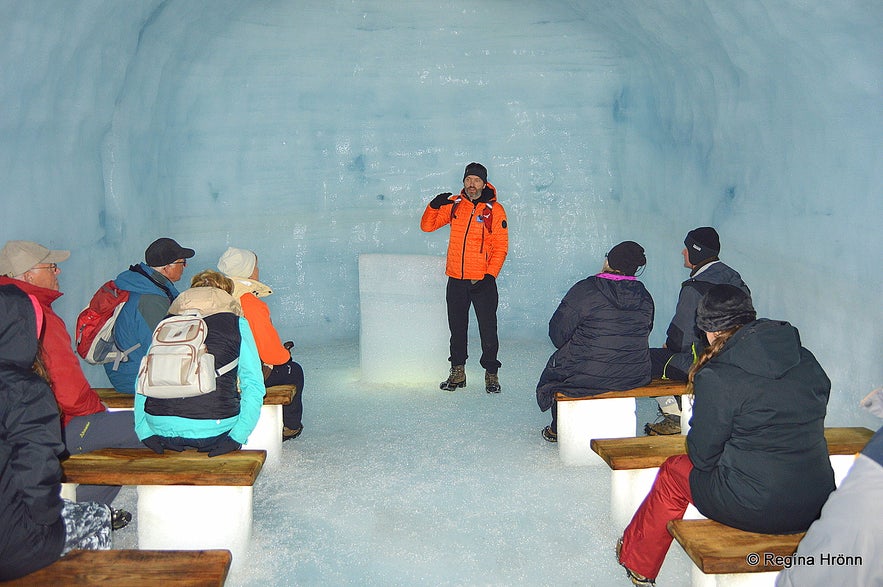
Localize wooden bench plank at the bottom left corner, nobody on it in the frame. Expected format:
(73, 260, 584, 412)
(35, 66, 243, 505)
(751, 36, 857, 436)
(4, 550, 233, 587)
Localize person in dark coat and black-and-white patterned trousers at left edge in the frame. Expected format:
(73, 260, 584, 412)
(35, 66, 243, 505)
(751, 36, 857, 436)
(0, 285, 111, 581)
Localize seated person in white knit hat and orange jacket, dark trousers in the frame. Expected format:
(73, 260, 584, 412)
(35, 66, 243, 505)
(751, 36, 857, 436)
(218, 247, 304, 441)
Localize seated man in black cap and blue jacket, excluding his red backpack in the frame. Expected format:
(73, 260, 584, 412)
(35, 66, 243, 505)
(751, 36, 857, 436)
(104, 238, 194, 393)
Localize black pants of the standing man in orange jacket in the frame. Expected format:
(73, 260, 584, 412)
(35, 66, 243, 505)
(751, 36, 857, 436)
(445, 275, 500, 373)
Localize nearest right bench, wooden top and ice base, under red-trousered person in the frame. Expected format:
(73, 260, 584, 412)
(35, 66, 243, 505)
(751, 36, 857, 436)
(668, 520, 805, 587)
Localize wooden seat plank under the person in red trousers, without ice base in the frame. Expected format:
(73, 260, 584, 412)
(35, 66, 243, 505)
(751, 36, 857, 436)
(668, 520, 805, 574)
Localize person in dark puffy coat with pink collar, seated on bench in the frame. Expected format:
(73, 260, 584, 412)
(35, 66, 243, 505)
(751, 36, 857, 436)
(536, 241, 654, 442)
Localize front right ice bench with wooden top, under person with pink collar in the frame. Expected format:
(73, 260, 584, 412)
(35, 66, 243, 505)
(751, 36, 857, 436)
(555, 379, 692, 465)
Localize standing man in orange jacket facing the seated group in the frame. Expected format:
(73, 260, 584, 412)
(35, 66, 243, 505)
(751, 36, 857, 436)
(420, 163, 509, 393)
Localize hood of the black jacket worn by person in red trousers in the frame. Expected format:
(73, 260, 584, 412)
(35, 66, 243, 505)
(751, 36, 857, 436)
(712, 318, 801, 379)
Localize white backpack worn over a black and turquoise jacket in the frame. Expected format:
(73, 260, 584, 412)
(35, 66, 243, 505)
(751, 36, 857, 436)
(137, 310, 239, 399)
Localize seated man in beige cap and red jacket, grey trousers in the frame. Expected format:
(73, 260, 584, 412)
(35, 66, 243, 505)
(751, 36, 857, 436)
(0, 241, 143, 530)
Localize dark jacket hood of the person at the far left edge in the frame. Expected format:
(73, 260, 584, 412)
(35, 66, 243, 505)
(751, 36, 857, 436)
(0, 285, 37, 369)
